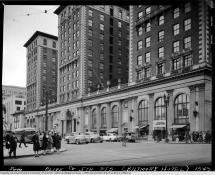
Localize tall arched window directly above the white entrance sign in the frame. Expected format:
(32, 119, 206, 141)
(155, 97, 166, 120)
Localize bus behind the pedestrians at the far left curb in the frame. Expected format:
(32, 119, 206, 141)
(14, 128, 36, 143)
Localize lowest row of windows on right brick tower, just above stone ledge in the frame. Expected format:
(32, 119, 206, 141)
(137, 54, 193, 80)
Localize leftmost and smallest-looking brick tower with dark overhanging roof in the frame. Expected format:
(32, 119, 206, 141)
(24, 31, 58, 112)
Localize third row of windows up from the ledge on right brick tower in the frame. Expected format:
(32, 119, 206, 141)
(137, 18, 191, 36)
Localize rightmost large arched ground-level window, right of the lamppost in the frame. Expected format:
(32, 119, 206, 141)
(174, 94, 190, 124)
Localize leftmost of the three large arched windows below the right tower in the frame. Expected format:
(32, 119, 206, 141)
(138, 100, 149, 125)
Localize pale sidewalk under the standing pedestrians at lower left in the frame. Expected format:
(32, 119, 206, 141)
(3, 144, 67, 159)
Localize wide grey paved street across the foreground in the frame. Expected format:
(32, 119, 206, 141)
(4, 142, 211, 166)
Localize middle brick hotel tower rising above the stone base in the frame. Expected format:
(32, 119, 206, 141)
(54, 5, 129, 104)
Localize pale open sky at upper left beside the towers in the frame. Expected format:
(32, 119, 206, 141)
(2, 5, 58, 87)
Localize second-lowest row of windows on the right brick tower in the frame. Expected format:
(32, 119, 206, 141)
(137, 36, 191, 52)
